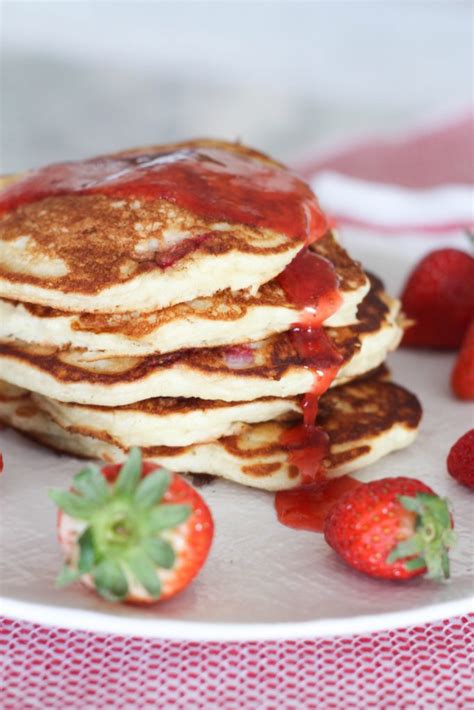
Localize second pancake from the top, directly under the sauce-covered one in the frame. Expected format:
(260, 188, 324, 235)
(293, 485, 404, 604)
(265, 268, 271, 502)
(0, 233, 369, 357)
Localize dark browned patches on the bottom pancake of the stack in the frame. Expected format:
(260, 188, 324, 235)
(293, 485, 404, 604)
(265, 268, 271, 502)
(0, 372, 422, 487)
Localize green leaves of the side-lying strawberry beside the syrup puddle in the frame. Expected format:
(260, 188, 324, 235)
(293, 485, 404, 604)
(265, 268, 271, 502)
(387, 493, 456, 579)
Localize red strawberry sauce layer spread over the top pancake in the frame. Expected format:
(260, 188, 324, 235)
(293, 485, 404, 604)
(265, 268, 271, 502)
(0, 146, 327, 244)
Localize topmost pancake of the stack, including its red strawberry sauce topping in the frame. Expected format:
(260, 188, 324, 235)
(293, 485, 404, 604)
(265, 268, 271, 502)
(0, 140, 327, 313)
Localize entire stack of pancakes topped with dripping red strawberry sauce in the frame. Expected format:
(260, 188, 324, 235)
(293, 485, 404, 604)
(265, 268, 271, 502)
(0, 141, 421, 490)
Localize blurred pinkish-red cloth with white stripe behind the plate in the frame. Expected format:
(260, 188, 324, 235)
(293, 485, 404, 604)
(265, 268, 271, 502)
(299, 113, 474, 237)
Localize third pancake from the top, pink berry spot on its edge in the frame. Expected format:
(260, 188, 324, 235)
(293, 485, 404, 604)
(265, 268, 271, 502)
(0, 280, 402, 407)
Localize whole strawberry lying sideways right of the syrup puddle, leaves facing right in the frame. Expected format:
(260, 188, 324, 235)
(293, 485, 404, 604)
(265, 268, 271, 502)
(324, 477, 455, 580)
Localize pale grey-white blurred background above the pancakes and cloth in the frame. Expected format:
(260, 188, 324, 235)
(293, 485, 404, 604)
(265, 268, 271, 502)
(0, 0, 473, 172)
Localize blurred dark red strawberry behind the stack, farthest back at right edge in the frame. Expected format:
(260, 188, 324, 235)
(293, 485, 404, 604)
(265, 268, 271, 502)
(401, 249, 474, 348)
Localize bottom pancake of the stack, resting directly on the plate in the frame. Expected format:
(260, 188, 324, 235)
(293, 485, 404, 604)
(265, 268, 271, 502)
(0, 377, 421, 491)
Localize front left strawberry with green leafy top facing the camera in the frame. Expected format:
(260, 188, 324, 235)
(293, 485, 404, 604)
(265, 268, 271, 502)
(50, 448, 213, 604)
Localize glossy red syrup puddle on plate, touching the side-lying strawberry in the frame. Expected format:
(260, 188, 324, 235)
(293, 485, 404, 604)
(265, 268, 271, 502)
(275, 476, 364, 532)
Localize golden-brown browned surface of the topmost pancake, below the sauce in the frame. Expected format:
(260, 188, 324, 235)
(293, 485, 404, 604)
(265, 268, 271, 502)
(0, 140, 312, 294)
